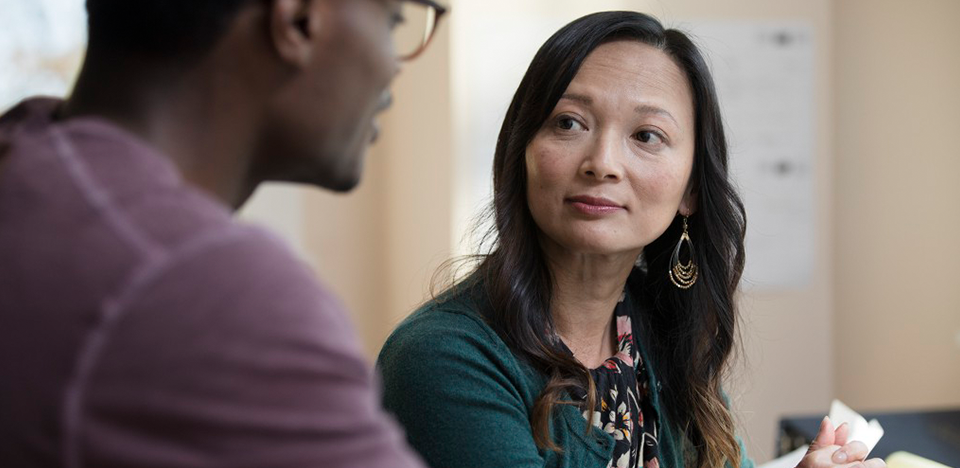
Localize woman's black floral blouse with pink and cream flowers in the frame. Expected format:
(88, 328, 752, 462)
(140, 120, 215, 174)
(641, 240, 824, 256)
(564, 298, 660, 468)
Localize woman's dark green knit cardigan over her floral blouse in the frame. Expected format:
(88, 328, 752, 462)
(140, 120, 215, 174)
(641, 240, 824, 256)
(377, 288, 753, 468)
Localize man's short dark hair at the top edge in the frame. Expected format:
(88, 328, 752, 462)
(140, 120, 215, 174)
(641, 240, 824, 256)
(87, 0, 251, 58)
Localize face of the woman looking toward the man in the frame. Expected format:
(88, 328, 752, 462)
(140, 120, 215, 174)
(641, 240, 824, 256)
(526, 41, 696, 255)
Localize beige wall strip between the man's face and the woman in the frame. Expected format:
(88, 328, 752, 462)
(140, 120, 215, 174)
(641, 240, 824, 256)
(304, 19, 454, 361)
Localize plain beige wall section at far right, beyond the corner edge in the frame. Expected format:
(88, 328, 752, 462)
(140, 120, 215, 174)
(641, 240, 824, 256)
(833, 0, 960, 409)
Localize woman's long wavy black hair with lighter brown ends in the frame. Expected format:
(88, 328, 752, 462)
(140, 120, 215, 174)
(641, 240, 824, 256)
(446, 11, 746, 468)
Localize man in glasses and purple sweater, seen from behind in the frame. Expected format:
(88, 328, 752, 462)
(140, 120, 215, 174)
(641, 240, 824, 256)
(0, 0, 442, 468)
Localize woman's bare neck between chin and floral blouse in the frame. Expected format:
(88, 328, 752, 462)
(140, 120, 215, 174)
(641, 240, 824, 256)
(544, 239, 640, 369)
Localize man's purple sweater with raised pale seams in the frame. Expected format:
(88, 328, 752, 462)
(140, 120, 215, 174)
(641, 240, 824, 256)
(0, 99, 421, 468)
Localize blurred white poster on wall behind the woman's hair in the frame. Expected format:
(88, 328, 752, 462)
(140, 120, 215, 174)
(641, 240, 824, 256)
(679, 21, 816, 289)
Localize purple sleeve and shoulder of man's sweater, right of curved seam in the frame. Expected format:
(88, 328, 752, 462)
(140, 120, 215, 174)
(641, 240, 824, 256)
(75, 225, 421, 468)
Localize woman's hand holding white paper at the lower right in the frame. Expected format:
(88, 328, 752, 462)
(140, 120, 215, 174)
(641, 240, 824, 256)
(797, 417, 887, 468)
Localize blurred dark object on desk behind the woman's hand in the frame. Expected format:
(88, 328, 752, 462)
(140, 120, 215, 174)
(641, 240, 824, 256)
(777, 409, 960, 468)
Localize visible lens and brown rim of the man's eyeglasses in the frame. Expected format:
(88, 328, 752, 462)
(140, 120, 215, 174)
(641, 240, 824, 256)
(393, 0, 447, 61)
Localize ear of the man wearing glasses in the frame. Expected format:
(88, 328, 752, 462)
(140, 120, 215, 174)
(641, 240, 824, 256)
(267, 0, 320, 68)
